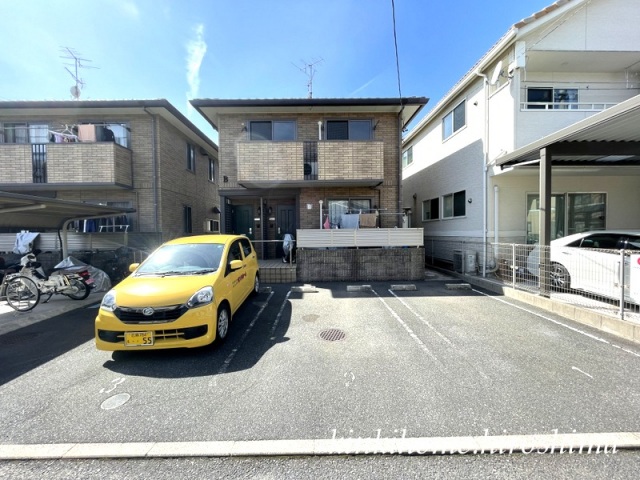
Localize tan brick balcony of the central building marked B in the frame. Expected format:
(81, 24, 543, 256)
(237, 141, 384, 188)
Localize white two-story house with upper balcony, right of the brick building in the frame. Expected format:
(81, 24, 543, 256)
(402, 0, 640, 270)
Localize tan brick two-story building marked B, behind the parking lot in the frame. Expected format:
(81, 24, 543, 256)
(191, 97, 427, 257)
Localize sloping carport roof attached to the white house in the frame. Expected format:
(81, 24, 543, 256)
(496, 95, 640, 168)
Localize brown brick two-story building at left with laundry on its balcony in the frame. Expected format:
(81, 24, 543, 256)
(0, 100, 220, 247)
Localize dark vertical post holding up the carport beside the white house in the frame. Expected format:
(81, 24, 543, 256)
(538, 148, 552, 297)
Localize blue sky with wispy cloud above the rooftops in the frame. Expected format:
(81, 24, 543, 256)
(0, 0, 553, 140)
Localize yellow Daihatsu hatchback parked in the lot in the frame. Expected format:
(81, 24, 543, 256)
(95, 235, 260, 351)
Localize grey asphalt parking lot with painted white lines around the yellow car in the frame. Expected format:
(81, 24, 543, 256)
(0, 274, 640, 478)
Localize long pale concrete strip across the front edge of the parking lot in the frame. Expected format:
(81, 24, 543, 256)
(0, 431, 640, 460)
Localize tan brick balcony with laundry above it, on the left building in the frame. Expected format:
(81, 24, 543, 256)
(0, 142, 133, 191)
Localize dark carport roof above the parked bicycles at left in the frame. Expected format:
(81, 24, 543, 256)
(0, 191, 135, 230)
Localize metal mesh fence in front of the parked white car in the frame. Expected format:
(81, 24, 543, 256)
(425, 239, 640, 323)
